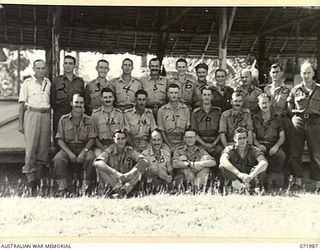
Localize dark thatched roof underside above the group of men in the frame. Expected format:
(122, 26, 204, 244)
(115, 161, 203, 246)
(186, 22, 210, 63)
(0, 4, 320, 57)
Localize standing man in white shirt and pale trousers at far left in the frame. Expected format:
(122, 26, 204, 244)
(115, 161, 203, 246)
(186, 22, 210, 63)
(19, 60, 51, 195)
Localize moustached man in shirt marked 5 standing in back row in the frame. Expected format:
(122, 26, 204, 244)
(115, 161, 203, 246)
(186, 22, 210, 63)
(140, 58, 168, 119)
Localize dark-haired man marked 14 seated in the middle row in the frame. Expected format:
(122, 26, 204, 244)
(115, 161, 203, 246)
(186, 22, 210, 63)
(124, 89, 157, 152)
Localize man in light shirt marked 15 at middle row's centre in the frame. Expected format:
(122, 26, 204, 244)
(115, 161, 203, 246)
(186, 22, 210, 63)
(157, 83, 190, 152)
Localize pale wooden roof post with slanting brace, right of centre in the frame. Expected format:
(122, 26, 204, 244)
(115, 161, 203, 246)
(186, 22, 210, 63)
(219, 7, 227, 69)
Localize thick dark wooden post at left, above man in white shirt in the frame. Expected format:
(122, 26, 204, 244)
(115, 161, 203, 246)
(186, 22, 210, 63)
(46, 6, 61, 80)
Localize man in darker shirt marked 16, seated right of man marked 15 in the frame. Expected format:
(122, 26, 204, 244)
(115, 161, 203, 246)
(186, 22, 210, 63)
(191, 86, 223, 159)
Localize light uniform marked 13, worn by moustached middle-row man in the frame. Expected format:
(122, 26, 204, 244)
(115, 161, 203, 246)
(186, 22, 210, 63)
(91, 107, 124, 156)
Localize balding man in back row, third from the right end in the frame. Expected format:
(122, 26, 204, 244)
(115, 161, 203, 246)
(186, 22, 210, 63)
(236, 69, 262, 112)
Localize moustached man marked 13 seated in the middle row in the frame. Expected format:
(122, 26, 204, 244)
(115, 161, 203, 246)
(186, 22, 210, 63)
(92, 88, 124, 157)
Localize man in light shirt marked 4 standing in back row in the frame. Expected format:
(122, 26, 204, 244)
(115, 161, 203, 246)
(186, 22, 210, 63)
(111, 58, 142, 111)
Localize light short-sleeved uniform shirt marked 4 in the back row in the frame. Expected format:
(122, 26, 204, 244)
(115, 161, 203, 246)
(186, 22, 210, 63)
(110, 75, 142, 111)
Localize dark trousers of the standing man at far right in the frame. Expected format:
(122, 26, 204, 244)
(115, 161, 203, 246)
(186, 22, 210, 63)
(290, 115, 320, 181)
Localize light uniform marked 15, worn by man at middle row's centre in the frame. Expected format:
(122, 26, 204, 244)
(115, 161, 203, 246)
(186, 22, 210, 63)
(157, 102, 190, 147)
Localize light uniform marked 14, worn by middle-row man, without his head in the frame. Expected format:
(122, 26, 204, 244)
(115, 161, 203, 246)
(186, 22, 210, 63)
(124, 107, 157, 152)
